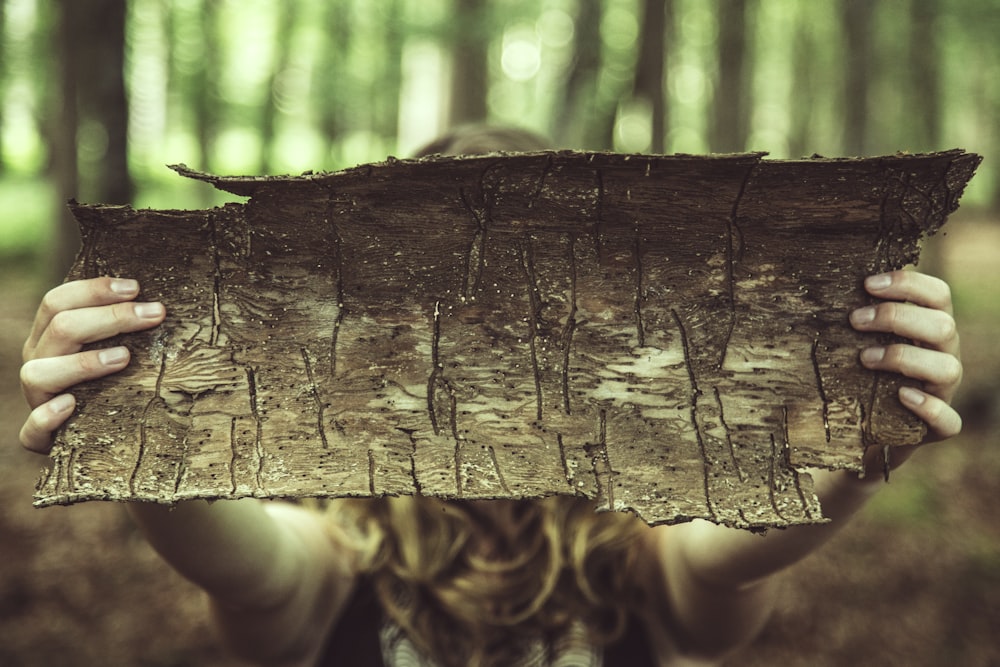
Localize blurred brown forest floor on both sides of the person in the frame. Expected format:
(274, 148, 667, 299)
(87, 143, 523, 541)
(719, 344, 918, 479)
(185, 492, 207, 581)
(0, 219, 1000, 667)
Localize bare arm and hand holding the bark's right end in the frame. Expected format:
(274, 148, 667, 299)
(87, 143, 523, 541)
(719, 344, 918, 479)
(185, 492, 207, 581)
(651, 271, 962, 653)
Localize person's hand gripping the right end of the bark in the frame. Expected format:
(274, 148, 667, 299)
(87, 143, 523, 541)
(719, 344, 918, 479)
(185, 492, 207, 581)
(850, 271, 962, 464)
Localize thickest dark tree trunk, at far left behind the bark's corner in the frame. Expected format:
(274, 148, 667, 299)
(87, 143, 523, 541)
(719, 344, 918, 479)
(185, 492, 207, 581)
(52, 0, 133, 275)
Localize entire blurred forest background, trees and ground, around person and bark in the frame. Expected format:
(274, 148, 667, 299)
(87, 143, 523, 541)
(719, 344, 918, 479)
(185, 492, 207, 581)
(0, 0, 1000, 666)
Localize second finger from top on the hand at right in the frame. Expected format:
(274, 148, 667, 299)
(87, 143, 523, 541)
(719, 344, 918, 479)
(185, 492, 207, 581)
(850, 301, 959, 355)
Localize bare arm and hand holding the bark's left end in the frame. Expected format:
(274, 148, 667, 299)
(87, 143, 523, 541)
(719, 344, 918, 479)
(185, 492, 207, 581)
(21, 278, 353, 665)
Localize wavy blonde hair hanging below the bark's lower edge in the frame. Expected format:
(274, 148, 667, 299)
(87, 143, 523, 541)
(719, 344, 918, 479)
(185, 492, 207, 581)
(330, 496, 645, 667)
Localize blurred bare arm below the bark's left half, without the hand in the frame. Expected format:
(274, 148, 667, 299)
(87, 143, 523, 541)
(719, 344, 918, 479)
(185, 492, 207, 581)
(129, 498, 354, 666)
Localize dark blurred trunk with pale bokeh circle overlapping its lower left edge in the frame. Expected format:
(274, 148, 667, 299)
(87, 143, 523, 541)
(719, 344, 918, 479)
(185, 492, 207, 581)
(632, 0, 673, 153)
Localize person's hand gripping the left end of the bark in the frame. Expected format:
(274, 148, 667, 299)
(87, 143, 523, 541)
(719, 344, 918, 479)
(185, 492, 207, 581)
(21, 278, 166, 453)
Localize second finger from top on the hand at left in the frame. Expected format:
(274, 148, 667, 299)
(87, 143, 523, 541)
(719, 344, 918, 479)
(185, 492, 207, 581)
(29, 302, 166, 359)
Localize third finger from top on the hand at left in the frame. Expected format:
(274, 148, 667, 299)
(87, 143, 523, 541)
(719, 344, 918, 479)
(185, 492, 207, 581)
(21, 346, 129, 408)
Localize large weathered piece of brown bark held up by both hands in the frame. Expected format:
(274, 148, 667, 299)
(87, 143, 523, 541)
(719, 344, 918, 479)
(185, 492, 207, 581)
(36, 151, 979, 526)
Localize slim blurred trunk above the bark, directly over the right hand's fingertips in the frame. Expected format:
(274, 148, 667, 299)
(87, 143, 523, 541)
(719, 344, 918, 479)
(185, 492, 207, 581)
(841, 0, 873, 155)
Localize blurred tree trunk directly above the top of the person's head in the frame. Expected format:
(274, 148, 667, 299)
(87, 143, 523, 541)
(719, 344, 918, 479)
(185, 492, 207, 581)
(448, 0, 489, 126)
